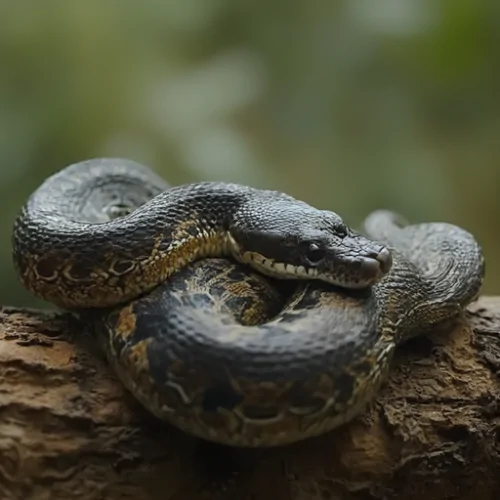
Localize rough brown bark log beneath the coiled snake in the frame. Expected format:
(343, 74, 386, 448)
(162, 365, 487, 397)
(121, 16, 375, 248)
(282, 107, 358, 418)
(0, 297, 500, 500)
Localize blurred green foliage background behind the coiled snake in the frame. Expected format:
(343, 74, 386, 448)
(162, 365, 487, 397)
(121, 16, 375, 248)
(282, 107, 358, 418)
(0, 0, 500, 306)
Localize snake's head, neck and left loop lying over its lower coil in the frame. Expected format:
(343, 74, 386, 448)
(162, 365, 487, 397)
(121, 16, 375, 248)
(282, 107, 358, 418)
(13, 159, 391, 308)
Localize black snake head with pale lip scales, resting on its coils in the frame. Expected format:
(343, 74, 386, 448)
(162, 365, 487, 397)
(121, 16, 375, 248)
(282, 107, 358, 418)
(229, 200, 392, 289)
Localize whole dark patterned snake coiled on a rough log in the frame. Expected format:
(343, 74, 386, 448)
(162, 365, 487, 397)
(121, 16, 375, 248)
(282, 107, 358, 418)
(12, 158, 485, 447)
